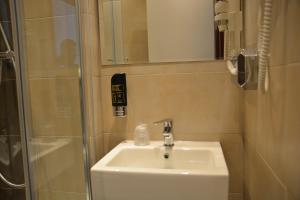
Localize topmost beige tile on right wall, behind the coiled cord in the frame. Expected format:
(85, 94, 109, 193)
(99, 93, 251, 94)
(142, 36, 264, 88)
(245, 0, 300, 67)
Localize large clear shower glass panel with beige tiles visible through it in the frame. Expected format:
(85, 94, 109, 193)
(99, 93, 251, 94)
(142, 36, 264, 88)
(10, 0, 90, 200)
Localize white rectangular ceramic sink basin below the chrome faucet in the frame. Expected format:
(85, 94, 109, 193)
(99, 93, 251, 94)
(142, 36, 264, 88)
(91, 141, 229, 200)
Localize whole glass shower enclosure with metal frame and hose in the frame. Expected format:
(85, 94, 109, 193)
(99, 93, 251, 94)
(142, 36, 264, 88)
(0, 0, 91, 200)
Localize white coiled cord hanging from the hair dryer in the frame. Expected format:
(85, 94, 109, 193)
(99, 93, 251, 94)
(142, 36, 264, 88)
(258, 0, 272, 92)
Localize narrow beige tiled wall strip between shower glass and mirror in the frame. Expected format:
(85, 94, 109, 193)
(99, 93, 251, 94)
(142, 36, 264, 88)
(80, 0, 103, 165)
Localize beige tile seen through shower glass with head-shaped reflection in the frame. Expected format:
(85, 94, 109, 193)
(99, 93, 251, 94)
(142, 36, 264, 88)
(24, 15, 80, 77)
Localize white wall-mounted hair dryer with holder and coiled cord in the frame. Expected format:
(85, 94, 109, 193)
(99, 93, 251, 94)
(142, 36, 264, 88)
(215, 0, 272, 91)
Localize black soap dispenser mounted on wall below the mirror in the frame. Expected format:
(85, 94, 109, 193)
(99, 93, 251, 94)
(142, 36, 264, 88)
(111, 73, 127, 117)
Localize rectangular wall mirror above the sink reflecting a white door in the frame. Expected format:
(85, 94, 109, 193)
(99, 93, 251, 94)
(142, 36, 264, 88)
(99, 0, 223, 65)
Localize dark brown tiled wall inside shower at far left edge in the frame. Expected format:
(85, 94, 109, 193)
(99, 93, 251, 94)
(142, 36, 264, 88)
(0, 0, 25, 200)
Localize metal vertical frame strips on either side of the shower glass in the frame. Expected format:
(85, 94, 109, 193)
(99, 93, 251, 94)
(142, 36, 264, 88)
(9, 0, 92, 200)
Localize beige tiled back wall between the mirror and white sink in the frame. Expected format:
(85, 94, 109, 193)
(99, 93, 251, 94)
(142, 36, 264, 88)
(101, 61, 243, 199)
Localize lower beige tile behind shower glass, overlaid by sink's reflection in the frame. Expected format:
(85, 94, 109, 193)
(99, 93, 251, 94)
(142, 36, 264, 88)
(30, 137, 86, 193)
